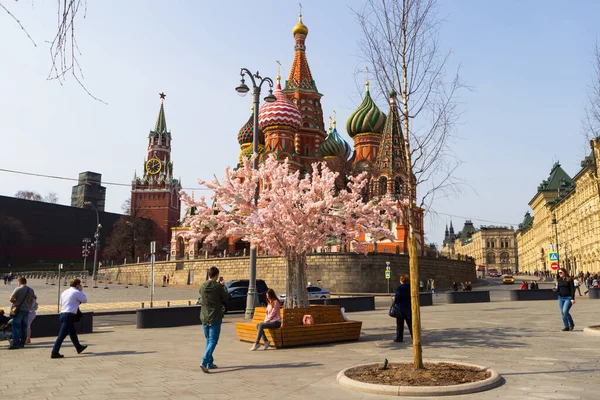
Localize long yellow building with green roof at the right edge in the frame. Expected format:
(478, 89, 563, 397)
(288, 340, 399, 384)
(517, 138, 600, 274)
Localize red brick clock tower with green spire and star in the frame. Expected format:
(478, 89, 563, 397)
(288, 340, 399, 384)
(131, 93, 181, 252)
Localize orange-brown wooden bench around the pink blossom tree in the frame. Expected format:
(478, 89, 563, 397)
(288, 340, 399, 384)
(235, 305, 362, 348)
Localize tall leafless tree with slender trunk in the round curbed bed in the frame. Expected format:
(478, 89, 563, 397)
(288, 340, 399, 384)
(355, 0, 463, 369)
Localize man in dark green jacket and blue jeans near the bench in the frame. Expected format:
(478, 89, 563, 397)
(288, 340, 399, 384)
(199, 267, 229, 373)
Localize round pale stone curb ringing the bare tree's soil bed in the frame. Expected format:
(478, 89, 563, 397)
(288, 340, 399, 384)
(336, 360, 502, 397)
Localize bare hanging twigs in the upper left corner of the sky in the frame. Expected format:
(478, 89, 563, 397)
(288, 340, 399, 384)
(0, 0, 106, 104)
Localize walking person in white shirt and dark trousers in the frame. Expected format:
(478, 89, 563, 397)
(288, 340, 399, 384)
(50, 278, 87, 358)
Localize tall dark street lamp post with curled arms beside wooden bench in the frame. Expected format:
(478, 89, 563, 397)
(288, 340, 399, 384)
(235, 68, 277, 319)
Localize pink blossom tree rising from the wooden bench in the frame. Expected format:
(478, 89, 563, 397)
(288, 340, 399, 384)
(182, 156, 400, 308)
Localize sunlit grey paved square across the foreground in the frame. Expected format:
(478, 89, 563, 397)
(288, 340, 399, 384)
(0, 300, 600, 400)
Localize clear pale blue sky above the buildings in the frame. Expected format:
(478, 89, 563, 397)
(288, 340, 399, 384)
(0, 0, 600, 244)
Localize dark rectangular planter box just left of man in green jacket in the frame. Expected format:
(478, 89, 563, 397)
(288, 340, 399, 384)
(135, 306, 202, 329)
